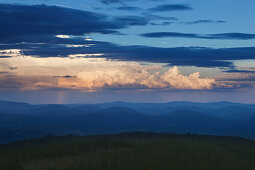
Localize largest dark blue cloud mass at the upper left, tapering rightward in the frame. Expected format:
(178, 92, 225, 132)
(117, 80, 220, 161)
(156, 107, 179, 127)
(0, 4, 124, 41)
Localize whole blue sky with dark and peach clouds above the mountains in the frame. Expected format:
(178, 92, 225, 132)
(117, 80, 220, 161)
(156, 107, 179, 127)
(0, 0, 255, 104)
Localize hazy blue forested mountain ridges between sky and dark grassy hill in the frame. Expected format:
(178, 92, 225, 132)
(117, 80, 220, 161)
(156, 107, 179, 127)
(0, 101, 255, 143)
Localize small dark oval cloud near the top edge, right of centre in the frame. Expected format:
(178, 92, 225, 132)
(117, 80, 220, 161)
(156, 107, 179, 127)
(148, 4, 193, 12)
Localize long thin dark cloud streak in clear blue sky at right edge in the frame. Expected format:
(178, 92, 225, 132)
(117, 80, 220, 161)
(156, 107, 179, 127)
(141, 32, 255, 40)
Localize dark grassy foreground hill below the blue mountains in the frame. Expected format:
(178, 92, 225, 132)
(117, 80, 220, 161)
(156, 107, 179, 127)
(0, 132, 255, 170)
